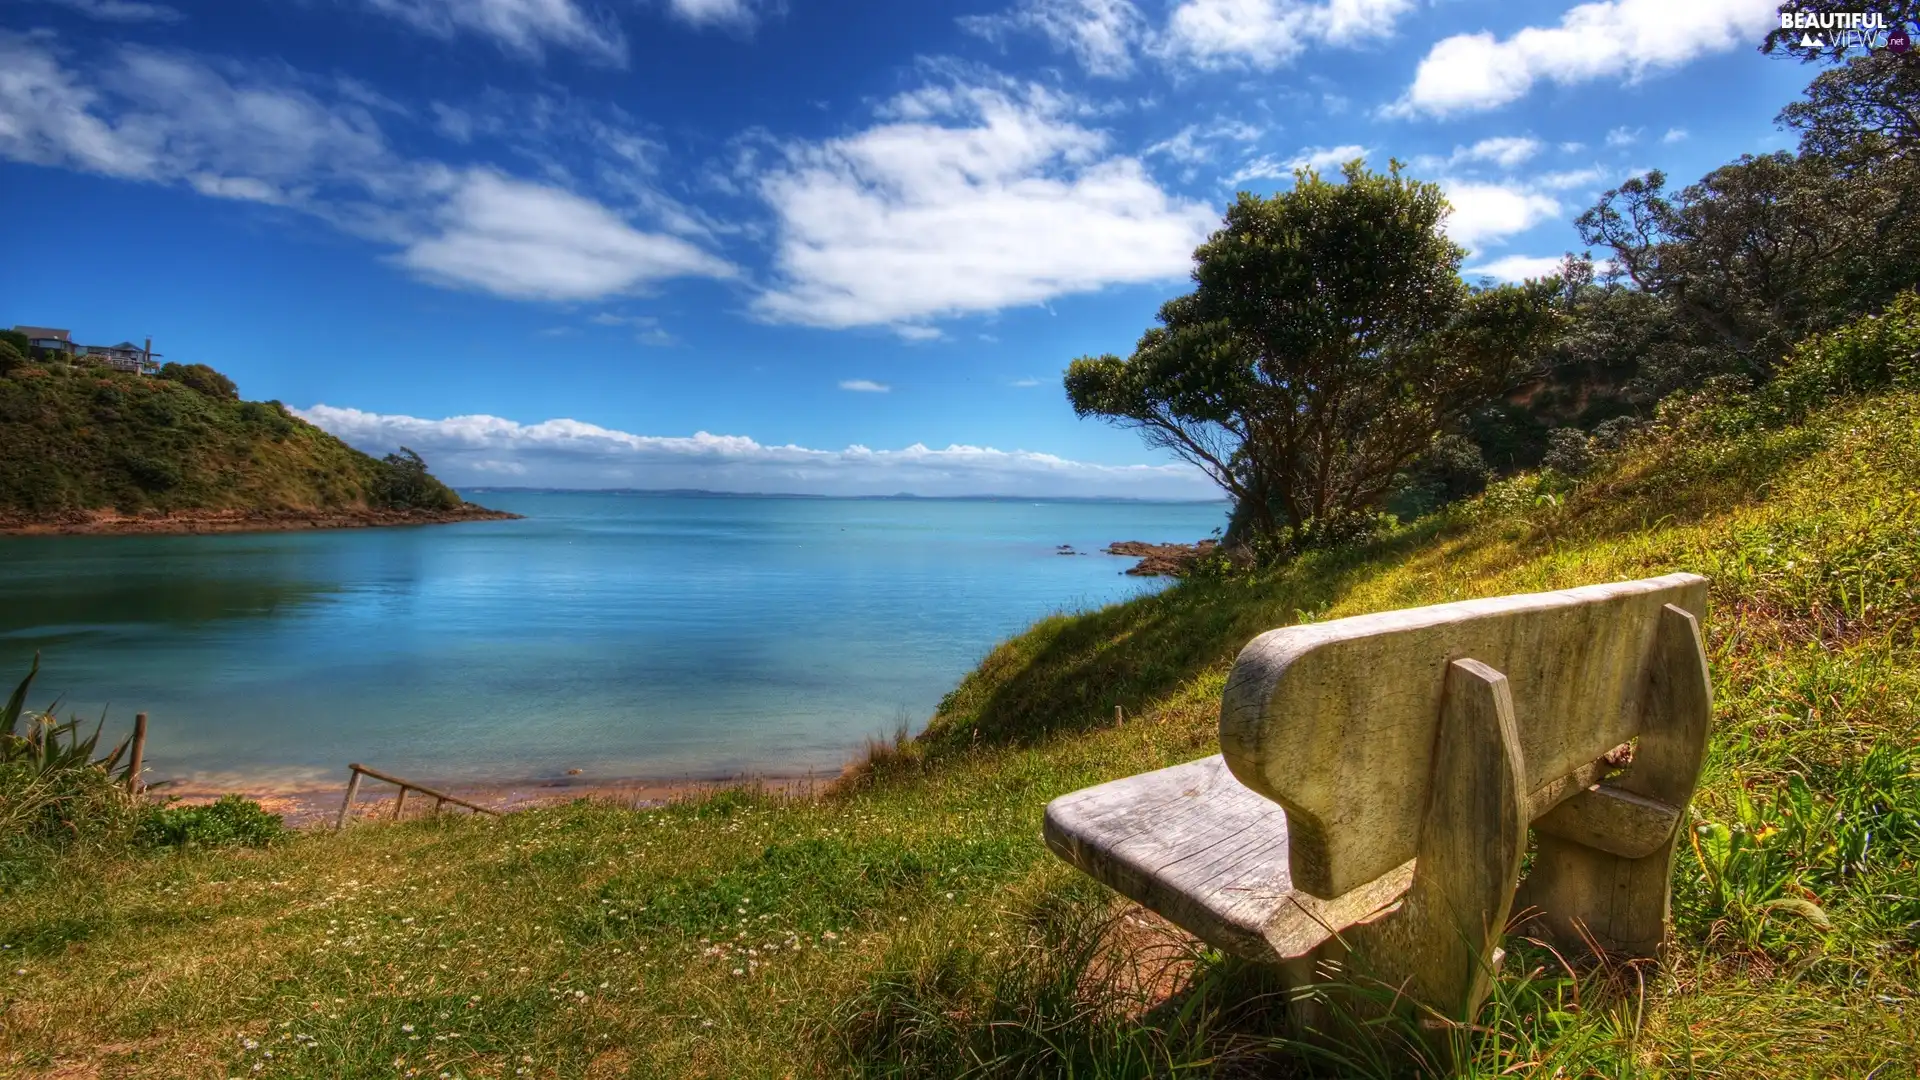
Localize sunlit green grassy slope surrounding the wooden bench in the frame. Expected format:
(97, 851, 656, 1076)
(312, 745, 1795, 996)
(0, 394, 1920, 1078)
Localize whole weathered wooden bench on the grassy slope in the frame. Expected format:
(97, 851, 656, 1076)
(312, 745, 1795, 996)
(1044, 575, 1713, 1020)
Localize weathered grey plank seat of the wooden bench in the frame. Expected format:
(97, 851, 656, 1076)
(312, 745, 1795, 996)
(1043, 753, 1413, 963)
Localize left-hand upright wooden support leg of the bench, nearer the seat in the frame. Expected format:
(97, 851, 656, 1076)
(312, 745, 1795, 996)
(1342, 659, 1528, 1032)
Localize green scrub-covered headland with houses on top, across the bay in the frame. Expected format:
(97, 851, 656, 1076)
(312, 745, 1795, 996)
(0, 363, 472, 519)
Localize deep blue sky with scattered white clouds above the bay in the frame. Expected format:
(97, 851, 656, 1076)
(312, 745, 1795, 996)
(0, 0, 1812, 498)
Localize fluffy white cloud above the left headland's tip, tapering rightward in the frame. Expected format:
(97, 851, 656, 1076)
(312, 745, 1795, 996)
(399, 169, 735, 300)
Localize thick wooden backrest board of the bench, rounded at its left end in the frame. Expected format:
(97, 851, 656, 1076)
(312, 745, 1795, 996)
(1219, 575, 1707, 899)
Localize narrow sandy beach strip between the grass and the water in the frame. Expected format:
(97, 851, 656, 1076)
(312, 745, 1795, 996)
(146, 771, 839, 828)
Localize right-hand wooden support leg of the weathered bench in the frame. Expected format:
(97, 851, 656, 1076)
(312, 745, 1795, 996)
(1517, 603, 1713, 957)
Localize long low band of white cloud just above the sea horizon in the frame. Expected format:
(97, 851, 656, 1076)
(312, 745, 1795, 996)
(296, 404, 1217, 498)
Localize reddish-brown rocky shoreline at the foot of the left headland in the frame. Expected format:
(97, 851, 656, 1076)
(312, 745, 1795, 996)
(0, 503, 524, 536)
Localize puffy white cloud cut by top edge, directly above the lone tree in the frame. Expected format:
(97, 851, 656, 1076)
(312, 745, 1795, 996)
(1150, 0, 1415, 69)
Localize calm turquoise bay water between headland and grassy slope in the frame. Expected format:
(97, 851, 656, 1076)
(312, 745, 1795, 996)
(0, 492, 1225, 782)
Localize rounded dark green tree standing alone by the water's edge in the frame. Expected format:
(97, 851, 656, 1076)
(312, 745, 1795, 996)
(1066, 161, 1557, 540)
